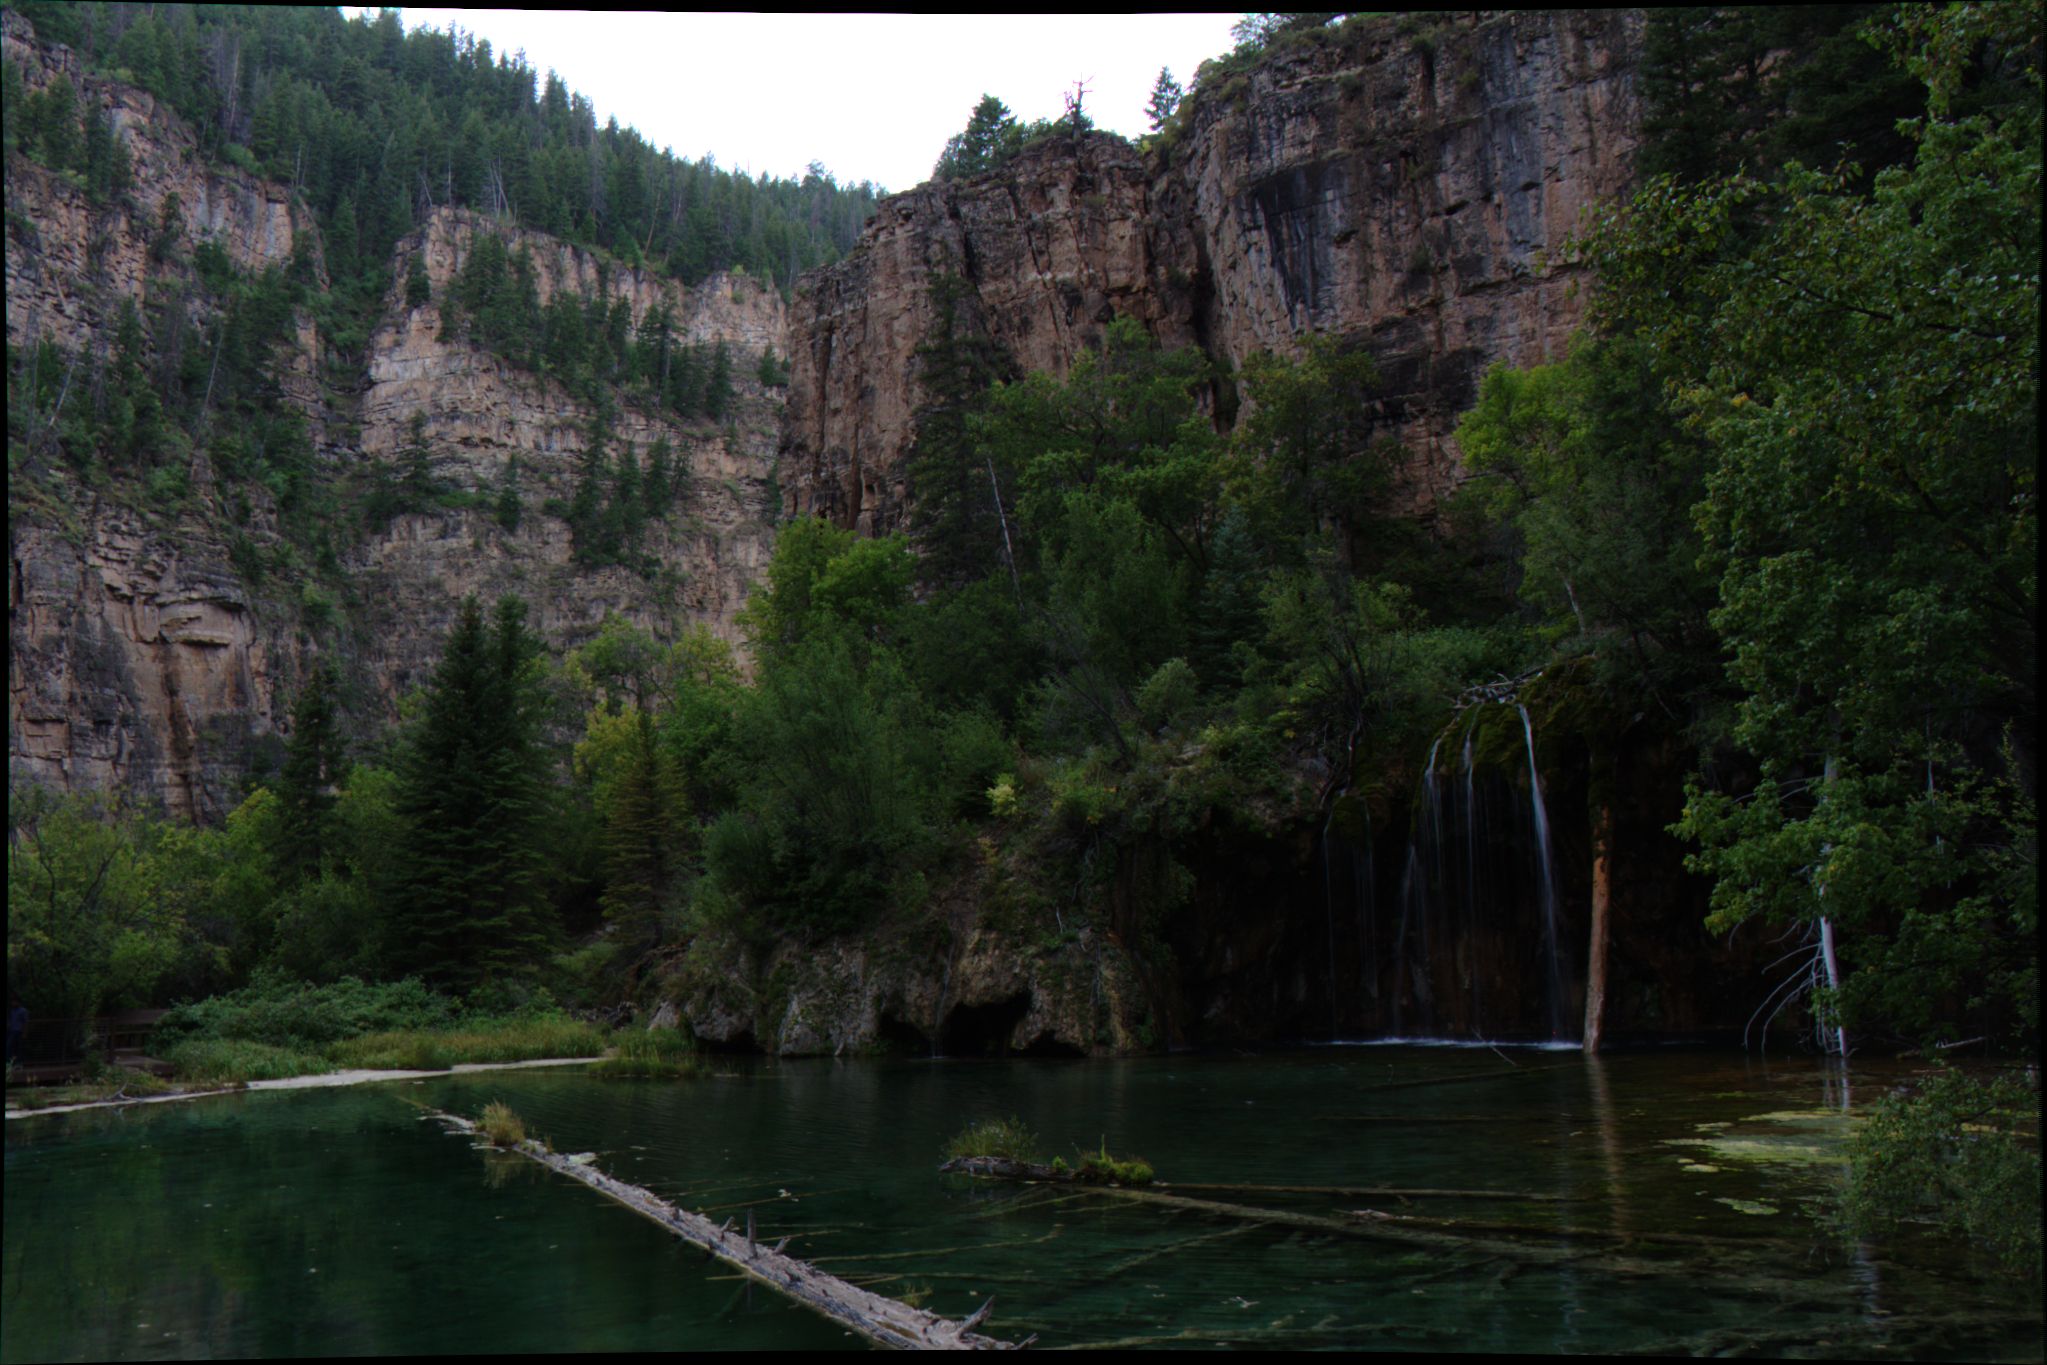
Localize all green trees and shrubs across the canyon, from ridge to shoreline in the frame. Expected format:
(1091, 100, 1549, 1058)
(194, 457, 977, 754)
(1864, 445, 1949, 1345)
(8, 4, 2041, 1275)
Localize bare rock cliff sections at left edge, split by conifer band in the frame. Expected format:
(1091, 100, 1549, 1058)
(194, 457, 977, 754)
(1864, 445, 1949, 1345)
(4, 12, 323, 814)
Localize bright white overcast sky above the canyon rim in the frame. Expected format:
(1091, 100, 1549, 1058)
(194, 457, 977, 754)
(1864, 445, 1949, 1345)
(342, 6, 1240, 190)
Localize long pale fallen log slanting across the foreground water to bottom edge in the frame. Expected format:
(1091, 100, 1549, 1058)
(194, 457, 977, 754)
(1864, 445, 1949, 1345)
(426, 1109, 1030, 1351)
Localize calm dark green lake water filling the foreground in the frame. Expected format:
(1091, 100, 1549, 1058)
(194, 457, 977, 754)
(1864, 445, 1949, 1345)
(0, 1046, 2041, 1361)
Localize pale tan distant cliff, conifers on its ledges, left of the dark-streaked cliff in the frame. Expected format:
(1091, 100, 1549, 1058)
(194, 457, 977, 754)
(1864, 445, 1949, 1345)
(348, 211, 784, 700)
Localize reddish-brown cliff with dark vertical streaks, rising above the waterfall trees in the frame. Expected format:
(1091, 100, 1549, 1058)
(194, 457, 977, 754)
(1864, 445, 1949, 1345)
(782, 10, 1642, 530)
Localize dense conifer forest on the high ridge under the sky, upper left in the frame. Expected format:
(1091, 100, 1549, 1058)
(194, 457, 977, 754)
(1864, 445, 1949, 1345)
(8, 0, 878, 289)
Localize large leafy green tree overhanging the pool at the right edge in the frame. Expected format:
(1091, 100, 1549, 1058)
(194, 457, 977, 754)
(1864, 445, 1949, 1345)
(1599, 6, 2041, 1036)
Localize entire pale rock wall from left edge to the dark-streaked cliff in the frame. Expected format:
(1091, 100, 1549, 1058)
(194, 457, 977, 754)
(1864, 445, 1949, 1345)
(4, 12, 786, 819)
